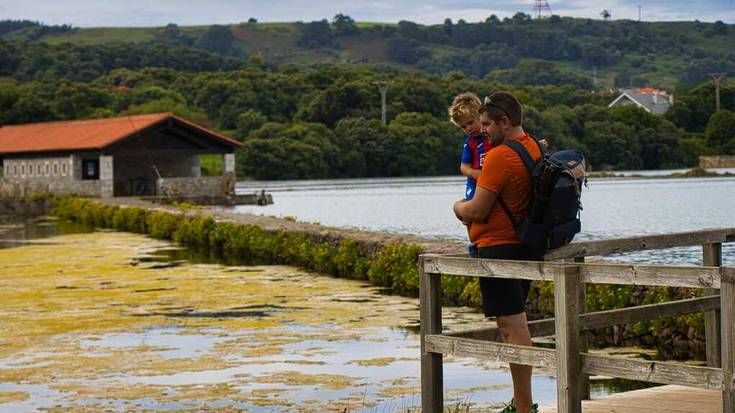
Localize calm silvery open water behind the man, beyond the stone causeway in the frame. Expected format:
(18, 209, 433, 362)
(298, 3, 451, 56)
(235, 177, 735, 265)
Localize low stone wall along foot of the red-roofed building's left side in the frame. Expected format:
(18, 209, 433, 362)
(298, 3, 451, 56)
(0, 178, 101, 197)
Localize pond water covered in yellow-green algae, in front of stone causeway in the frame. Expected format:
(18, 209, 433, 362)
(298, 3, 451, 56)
(0, 222, 656, 413)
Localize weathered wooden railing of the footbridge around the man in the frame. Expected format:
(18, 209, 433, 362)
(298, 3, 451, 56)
(419, 228, 735, 413)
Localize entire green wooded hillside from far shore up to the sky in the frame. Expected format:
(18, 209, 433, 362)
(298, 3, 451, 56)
(0, 18, 735, 179)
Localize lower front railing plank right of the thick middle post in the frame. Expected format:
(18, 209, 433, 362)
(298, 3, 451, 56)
(582, 353, 723, 389)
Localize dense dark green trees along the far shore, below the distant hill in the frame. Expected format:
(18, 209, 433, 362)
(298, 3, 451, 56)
(0, 62, 735, 179)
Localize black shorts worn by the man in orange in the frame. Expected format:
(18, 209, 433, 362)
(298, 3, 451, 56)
(479, 244, 540, 317)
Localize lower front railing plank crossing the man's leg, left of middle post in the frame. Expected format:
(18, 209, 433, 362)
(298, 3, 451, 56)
(426, 335, 556, 369)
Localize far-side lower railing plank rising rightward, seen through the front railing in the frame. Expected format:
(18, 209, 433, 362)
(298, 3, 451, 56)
(446, 296, 720, 341)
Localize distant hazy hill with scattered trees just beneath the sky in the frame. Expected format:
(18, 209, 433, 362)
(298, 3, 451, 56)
(0, 17, 735, 88)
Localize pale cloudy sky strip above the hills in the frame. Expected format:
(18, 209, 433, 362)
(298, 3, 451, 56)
(0, 0, 735, 27)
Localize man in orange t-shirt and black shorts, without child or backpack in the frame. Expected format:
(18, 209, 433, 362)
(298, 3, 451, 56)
(454, 92, 542, 413)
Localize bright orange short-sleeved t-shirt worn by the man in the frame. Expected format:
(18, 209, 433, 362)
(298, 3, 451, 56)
(470, 133, 541, 247)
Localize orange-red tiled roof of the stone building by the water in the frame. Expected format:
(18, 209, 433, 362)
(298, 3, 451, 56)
(0, 113, 242, 154)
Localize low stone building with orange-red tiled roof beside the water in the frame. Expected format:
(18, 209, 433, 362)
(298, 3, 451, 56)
(0, 113, 246, 196)
